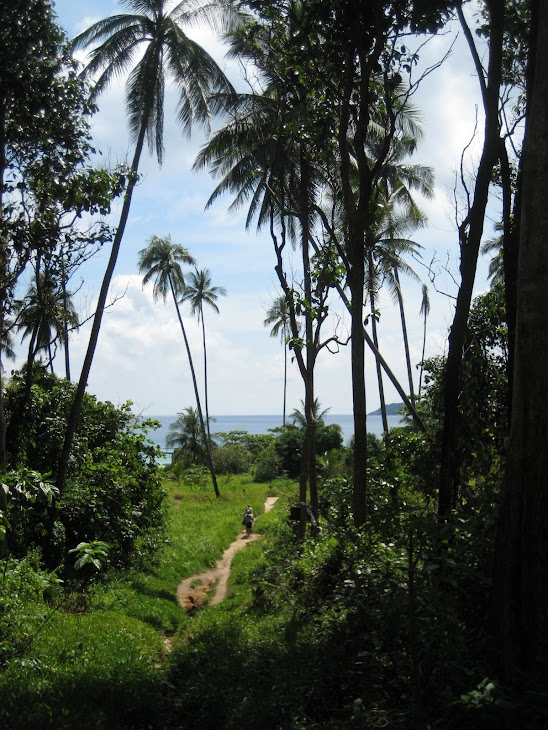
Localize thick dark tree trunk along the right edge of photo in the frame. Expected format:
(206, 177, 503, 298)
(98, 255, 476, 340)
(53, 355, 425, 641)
(491, 0, 548, 683)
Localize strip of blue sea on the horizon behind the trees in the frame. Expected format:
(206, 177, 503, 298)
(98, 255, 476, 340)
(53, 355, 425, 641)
(144, 413, 402, 456)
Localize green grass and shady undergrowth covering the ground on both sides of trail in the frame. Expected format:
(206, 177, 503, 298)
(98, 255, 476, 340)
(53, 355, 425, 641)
(0, 470, 548, 730)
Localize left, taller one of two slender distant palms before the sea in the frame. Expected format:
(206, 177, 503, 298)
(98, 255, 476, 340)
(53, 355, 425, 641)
(139, 236, 220, 497)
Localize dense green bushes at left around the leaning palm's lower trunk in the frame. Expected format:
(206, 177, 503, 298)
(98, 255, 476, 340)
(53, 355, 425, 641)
(4, 371, 165, 574)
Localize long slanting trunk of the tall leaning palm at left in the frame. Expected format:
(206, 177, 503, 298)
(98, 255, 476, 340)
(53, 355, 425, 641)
(56, 122, 146, 491)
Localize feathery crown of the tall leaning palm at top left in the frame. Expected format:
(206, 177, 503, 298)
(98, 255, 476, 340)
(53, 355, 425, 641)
(72, 0, 235, 163)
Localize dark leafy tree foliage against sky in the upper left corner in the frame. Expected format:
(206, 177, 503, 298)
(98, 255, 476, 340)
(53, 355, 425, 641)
(0, 0, 125, 338)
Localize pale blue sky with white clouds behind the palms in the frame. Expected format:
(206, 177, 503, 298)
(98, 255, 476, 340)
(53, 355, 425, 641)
(19, 0, 495, 416)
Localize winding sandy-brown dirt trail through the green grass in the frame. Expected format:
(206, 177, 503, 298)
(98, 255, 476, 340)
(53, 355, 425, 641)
(177, 497, 278, 613)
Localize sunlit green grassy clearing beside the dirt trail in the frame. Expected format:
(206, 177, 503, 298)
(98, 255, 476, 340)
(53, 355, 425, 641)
(0, 477, 286, 730)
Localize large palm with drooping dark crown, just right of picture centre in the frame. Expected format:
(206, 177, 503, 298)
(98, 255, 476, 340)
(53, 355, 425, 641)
(195, 35, 327, 534)
